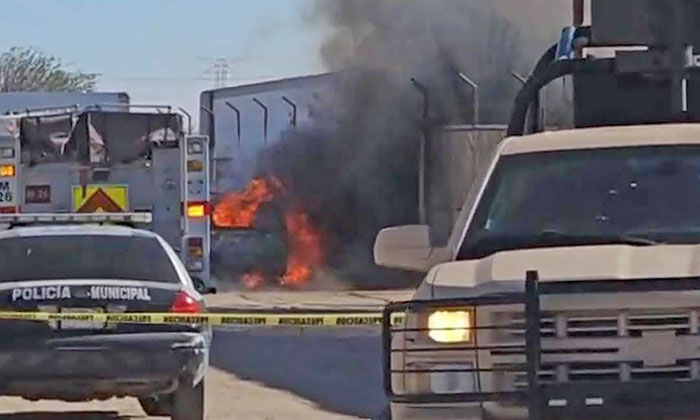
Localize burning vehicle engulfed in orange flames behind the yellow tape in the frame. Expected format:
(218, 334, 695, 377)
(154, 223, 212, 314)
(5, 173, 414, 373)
(212, 177, 323, 289)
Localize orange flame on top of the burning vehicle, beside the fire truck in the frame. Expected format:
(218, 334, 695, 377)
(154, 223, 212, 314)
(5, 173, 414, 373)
(211, 178, 282, 228)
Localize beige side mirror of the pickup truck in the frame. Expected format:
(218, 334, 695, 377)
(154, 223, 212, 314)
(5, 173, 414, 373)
(374, 225, 433, 272)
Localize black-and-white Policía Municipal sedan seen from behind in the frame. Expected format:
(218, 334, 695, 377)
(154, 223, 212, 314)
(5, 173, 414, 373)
(0, 213, 211, 420)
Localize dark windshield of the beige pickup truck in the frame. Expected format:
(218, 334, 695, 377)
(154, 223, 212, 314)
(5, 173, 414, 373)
(458, 146, 700, 259)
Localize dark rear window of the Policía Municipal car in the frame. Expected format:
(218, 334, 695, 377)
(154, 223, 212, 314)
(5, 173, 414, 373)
(0, 235, 180, 283)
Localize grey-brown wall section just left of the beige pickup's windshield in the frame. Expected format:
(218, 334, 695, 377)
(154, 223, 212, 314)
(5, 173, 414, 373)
(426, 126, 506, 244)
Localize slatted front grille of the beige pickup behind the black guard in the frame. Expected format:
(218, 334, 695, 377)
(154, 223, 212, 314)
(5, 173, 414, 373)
(492, 309, 700, 389)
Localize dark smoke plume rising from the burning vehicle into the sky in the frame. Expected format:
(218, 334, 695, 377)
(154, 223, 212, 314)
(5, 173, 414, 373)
(260, 0, 566, 286)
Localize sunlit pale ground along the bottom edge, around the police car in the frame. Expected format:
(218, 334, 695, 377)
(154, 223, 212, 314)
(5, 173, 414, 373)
(0, 368, 356, 420)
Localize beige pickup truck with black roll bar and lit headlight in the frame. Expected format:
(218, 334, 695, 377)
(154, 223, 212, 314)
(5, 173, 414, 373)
(374, 0, 700, 420)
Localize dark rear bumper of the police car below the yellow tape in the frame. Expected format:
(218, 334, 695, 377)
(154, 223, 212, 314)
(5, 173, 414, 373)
(0, 332, 209, 401)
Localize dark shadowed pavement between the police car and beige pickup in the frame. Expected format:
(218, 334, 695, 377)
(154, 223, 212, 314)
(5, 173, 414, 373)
(211, 327, 386, 418)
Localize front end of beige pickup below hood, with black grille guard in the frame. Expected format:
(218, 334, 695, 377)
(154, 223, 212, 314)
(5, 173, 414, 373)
(383, 273, 700, 420)
